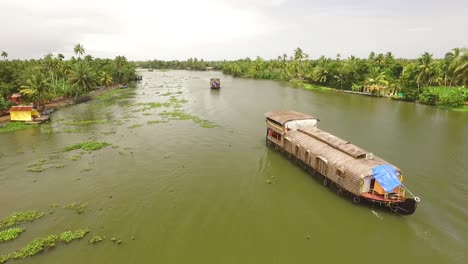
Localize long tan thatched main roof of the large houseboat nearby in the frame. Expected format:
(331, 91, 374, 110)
(286, 127, 400, 178)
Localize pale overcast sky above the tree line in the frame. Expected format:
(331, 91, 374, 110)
(0, 0, 468, 60)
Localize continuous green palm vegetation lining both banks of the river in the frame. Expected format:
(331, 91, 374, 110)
(0, 44, 468, 133)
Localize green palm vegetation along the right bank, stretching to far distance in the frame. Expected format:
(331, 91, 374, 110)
(137, 48, 468, 112)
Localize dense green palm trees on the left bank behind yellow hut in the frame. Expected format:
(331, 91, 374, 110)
(0, 44, 136, 111)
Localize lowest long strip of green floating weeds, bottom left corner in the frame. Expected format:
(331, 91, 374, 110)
(0, 229, 89, 263)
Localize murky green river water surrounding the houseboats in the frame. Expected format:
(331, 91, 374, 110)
(0, 71, 468, 264)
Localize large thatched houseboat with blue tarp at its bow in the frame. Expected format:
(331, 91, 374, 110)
(265, 111, 420, 215)
